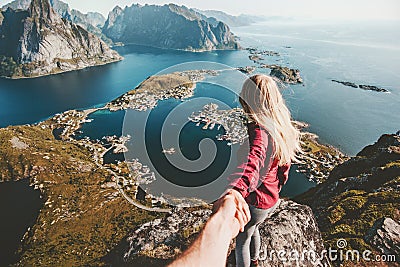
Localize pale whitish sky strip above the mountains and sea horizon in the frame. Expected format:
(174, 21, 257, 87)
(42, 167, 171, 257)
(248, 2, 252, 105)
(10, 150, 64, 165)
(0, 0, 400, 20)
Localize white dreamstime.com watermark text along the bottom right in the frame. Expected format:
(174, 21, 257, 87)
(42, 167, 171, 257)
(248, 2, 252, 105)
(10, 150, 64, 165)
(259, 238, 396, 266)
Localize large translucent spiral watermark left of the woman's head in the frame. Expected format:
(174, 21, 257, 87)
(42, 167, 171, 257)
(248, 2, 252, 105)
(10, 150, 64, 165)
(122, 62, 276, 205)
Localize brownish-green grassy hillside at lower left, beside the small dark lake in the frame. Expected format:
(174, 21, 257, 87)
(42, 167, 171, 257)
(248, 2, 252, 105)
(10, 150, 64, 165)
(0, 126, 159, 266)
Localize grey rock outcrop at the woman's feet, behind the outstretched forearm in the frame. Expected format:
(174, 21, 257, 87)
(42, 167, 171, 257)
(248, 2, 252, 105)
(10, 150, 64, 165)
(109, 200, 330, 266)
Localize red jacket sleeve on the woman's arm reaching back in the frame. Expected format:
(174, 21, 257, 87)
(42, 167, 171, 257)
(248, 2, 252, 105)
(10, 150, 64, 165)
(228, 128, 268, 198)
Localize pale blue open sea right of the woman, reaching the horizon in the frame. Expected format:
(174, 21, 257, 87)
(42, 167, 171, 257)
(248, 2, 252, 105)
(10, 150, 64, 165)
(234, 21, 400, 155)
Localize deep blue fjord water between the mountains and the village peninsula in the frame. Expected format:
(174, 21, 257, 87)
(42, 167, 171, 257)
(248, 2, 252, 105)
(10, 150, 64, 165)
(0, 46, 248, 127)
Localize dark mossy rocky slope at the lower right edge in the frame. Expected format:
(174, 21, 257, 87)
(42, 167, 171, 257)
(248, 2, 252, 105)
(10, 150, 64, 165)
(297, 135, 400, 266)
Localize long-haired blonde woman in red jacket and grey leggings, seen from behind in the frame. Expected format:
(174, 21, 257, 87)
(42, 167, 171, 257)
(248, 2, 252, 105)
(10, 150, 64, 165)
(228, 75, 301, 267)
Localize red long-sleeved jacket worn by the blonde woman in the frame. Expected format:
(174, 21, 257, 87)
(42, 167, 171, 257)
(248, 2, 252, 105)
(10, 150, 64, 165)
(229, 123, 290, 209)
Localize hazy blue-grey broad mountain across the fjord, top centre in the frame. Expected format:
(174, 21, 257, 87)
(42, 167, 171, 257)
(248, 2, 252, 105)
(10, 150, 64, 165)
(103, 4, 239, 51)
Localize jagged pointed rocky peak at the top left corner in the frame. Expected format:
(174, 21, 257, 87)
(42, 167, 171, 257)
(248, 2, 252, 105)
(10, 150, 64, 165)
(0, 0, 121, 77)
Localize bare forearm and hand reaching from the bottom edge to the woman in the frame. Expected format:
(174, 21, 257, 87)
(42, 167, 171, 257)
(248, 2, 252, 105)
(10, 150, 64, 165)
(169, 190, 250, 267)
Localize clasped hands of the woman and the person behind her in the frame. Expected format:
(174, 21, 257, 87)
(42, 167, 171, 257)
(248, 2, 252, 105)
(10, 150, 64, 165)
(213, 189, 251, 238)
